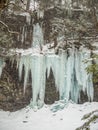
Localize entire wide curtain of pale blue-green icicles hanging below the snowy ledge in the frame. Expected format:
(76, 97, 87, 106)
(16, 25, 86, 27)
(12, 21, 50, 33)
(19, 46, 94, 107)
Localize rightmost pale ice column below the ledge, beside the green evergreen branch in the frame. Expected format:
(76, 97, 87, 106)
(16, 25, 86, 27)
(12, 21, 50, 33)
(80, 48, 94, 101)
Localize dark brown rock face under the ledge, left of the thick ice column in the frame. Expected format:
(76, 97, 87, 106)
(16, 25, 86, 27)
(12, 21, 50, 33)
(0, 60, 31, 111)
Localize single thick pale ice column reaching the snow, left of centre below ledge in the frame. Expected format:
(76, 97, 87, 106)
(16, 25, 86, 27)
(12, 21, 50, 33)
(31, 55, 45, 107)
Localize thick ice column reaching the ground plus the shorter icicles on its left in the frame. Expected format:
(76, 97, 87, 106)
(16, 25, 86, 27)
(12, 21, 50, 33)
(18, 54, 46, 107)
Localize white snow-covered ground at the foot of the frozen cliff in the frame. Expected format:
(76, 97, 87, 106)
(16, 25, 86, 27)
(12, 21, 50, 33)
(0, 102, 98, 130)
